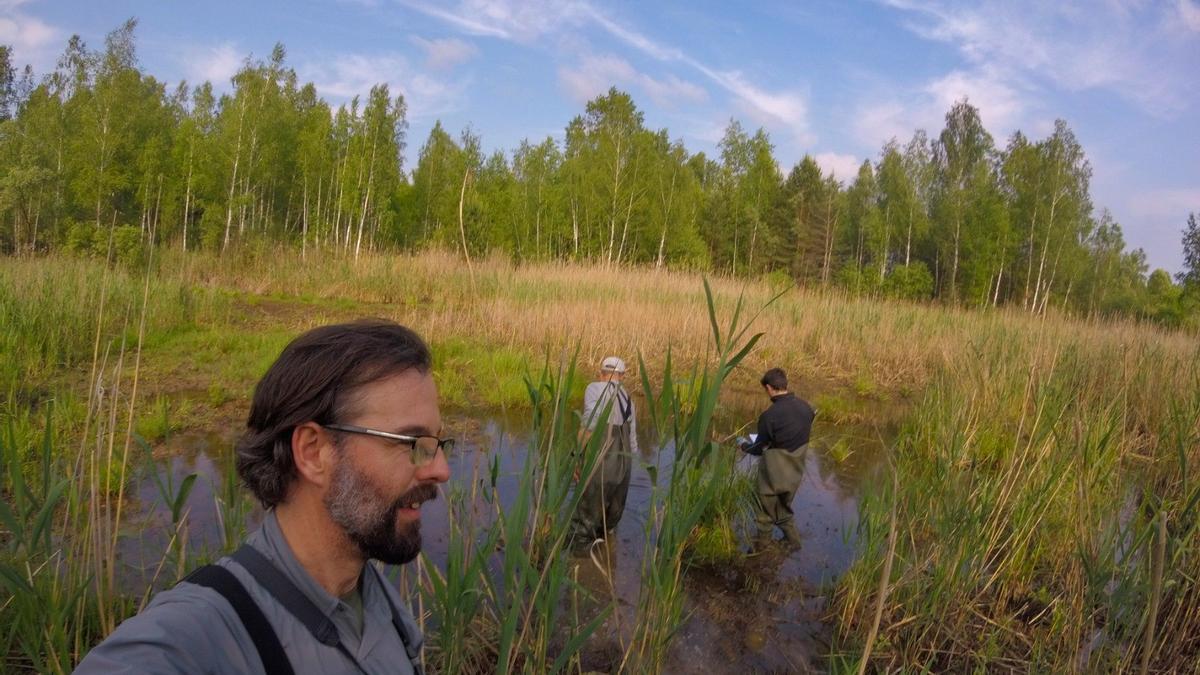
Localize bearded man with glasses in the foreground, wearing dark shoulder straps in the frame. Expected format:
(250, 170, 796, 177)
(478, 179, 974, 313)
(76, 319, 454, 674)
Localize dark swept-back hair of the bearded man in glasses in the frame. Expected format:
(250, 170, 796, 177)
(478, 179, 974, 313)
(235, 318, 431, 508)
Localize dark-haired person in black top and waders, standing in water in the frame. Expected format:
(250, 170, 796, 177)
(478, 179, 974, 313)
(740, 368, 816, 550)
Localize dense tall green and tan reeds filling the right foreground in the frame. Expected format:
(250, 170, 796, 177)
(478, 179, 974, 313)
(835, 324, 1200, 671)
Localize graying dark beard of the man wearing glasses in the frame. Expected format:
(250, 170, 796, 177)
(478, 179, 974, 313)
(325, 456, 424, 565)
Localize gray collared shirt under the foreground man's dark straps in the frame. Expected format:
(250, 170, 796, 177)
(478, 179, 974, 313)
(76, 512, 421, 675)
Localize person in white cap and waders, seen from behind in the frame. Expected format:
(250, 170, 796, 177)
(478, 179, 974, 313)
(571, 357, 637, 546)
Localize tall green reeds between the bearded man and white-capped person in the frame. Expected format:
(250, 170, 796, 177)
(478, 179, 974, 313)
(420, 359, 612, 673)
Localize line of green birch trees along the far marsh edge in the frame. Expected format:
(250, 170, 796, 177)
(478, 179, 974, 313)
(0, 19, 1200, 325)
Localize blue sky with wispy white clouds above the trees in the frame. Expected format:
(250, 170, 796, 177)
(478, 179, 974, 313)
(0, 0, 1200, 271)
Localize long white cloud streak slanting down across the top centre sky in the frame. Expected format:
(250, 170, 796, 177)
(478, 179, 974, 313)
(403, 0, 815, 144)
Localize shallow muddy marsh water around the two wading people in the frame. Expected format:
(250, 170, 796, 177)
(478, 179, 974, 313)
(120, 401, 882, 674)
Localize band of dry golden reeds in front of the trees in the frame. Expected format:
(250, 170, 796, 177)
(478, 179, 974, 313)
(154, 243, 1198, 403)
